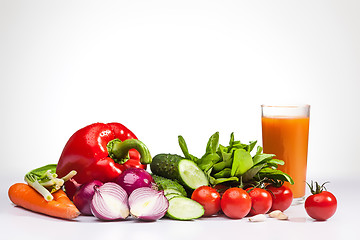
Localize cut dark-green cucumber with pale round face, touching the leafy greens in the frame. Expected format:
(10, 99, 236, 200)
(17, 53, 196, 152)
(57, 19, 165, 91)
(150, 154, 209, 190)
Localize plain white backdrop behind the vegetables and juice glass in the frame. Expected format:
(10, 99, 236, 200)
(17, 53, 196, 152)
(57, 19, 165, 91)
(0, 0, 360, 238)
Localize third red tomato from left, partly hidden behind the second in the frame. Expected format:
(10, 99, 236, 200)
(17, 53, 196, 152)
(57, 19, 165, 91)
(246, 188, 272, 215)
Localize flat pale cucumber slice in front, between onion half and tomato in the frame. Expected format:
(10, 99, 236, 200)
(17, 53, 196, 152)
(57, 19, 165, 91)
(166, 196, 205, 220)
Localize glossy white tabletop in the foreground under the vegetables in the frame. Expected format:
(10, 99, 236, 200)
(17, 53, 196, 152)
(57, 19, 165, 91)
(0, 174, 360, 240)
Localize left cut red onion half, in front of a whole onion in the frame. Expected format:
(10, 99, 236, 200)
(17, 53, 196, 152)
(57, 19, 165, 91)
(90, 182, 129, 220)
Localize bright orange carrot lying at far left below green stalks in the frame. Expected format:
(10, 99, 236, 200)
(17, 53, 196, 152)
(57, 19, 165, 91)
(8, 183, 80, 219)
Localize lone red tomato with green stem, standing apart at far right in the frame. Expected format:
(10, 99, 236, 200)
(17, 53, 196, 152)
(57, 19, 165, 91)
(305, 182, 337, 221)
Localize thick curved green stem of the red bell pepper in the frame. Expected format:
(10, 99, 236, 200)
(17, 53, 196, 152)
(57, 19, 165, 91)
(107, 139, 152, 164)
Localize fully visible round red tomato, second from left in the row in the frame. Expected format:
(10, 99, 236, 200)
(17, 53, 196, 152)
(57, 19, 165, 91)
(221, 188, 251, 219)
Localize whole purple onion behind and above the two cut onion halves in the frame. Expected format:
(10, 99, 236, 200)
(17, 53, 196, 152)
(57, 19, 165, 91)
(115, 168, 155, 195)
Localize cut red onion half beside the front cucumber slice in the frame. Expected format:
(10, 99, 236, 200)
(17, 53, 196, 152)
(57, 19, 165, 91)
(129, 187, 169, 221)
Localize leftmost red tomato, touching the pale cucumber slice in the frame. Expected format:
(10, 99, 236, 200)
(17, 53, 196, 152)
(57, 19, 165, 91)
(191, 186, 221, 216)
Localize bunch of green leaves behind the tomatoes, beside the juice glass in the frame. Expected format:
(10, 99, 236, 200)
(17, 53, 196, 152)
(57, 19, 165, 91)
(179, 132, 294, 186)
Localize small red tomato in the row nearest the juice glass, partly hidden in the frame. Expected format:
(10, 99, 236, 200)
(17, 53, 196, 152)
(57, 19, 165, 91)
(266, 185, 293, 212)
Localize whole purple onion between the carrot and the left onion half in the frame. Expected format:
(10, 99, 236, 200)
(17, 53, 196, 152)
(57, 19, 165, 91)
(73, 180, 104, 215)
